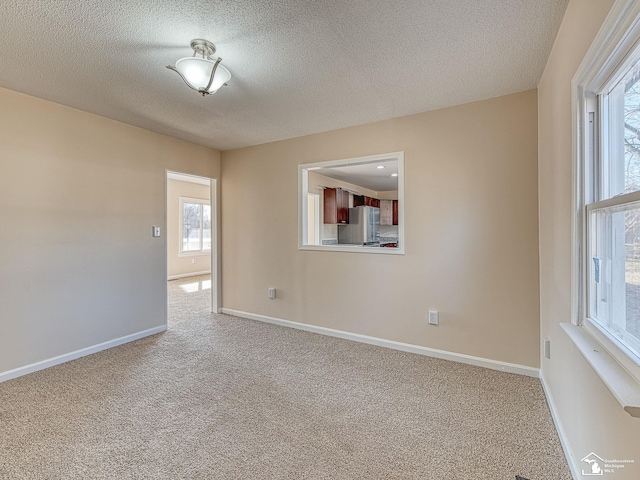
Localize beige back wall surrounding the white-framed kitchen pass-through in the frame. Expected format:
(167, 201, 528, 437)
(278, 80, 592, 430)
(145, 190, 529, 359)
(222, 91, 539, 367)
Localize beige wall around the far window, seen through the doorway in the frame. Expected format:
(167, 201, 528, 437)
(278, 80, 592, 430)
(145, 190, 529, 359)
(167, 178, 211, 278)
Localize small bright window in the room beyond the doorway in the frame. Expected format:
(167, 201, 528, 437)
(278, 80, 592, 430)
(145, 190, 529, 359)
(180, 197, 211, 254)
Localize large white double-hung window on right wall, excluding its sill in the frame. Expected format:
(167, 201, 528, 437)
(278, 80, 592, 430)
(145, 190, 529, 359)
(574, 2, 640, 365)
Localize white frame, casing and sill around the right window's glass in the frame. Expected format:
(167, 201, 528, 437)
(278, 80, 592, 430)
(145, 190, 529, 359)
(563, 0, 640, 416)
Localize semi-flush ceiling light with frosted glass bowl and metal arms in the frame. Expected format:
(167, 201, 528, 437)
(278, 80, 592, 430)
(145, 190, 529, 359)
(167, 38, 231, 97)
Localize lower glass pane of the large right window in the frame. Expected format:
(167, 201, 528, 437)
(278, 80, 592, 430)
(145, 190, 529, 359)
(589, 202, 640, 355)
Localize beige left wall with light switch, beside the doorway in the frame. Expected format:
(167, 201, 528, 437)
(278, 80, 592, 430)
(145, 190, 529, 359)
(0, 88, 219, 373)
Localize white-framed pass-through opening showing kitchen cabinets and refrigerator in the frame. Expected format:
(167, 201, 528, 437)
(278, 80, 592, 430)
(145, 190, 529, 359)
(298, 152, 404, 254)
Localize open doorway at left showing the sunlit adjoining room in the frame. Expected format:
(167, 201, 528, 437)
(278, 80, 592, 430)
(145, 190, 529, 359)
(166, 171, 219, 327)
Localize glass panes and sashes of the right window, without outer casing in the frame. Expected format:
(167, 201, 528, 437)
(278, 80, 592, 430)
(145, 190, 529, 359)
(586, 62, 640, 356)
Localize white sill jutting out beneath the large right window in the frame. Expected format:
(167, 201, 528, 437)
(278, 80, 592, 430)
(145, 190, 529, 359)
(560, 323, 640, 418)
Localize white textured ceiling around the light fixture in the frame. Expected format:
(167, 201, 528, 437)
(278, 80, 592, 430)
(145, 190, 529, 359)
(0, 0, 567, 150)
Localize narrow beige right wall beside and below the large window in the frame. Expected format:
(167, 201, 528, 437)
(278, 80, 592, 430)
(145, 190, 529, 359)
(538, 0, 640, 479)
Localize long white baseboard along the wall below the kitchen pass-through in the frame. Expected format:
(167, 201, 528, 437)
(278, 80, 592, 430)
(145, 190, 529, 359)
(222, 308, 540, 378)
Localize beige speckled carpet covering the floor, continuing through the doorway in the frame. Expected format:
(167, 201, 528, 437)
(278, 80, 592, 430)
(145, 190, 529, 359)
(0, 278, 571, 480)
